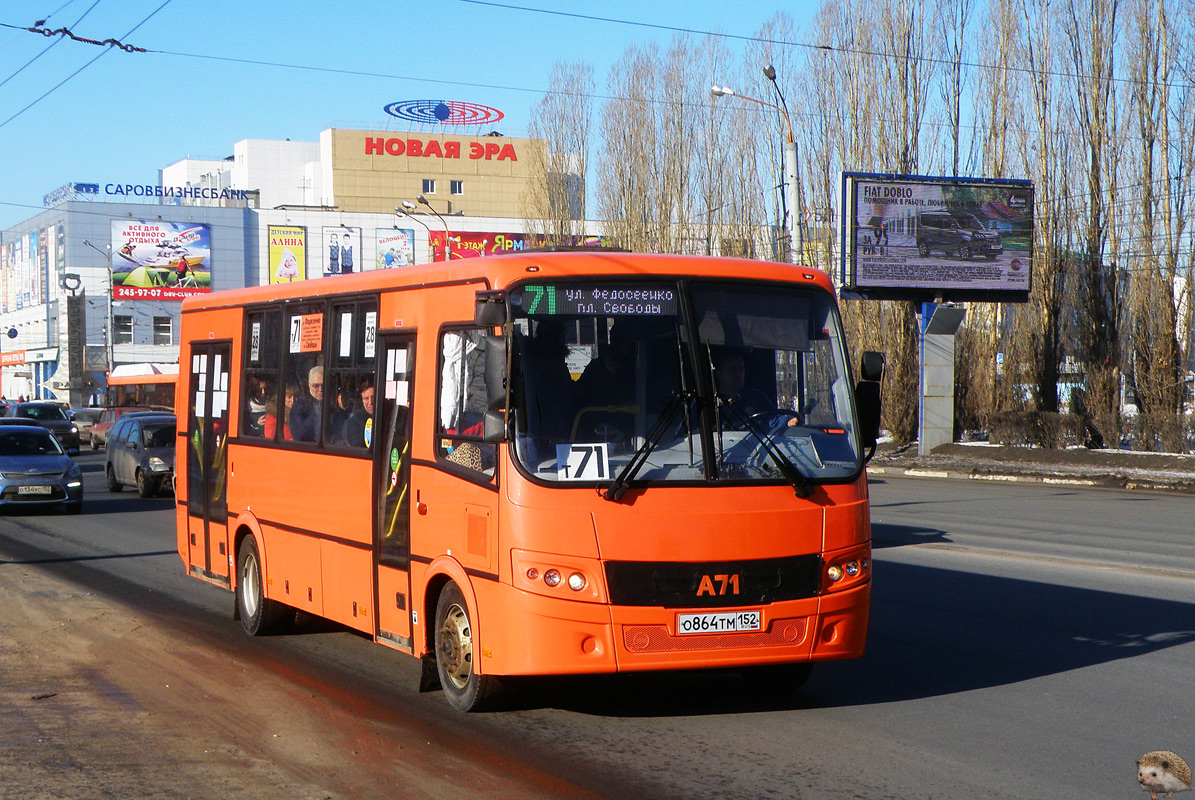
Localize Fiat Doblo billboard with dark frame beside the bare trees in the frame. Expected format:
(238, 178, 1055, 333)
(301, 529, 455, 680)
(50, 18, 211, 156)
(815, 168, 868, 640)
(840, 172, 1034, 303)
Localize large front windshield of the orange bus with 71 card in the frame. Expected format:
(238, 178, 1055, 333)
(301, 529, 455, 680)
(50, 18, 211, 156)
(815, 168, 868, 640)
(510, 280, 862, 487)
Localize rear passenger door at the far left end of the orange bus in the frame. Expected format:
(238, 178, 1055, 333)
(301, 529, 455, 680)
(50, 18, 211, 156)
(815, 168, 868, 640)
(184, 342, 232, 586)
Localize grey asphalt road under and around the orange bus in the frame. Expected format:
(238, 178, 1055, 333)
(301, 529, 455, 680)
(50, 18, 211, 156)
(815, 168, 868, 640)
(0, 454, 1195, 800)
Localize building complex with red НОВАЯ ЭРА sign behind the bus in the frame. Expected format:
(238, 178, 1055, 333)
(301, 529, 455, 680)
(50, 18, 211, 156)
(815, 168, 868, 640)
(0, 129, 573, 405)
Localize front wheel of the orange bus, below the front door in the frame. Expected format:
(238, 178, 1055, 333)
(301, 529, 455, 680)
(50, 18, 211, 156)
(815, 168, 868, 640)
(435, 582, 498, 712)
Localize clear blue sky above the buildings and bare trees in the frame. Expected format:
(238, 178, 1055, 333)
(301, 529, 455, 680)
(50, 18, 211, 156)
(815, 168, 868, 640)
(0, 0, 815, 230)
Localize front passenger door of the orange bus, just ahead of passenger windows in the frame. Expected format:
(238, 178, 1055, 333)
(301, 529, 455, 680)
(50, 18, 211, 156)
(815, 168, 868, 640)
(366, 334, 415, 653)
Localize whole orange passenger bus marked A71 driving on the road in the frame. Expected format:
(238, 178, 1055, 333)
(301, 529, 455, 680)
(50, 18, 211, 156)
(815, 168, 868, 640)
(177, 251, 882, 710)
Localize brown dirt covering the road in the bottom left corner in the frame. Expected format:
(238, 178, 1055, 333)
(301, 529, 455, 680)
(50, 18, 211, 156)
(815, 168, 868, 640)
(0, 554, 592, 800)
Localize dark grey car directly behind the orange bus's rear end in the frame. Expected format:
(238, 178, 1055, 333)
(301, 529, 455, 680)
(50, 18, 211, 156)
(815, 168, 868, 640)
(104, 413, 177, 497)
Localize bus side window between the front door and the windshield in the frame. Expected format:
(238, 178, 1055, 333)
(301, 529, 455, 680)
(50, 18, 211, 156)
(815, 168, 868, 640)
(436, 329, 497, 477)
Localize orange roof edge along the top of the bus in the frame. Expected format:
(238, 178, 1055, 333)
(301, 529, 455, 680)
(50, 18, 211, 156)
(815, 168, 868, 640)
(183, 250, 834, 313)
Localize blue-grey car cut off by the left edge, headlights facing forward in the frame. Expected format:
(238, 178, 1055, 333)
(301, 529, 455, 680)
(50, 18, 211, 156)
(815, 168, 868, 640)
(0, 422, 82, 514)
